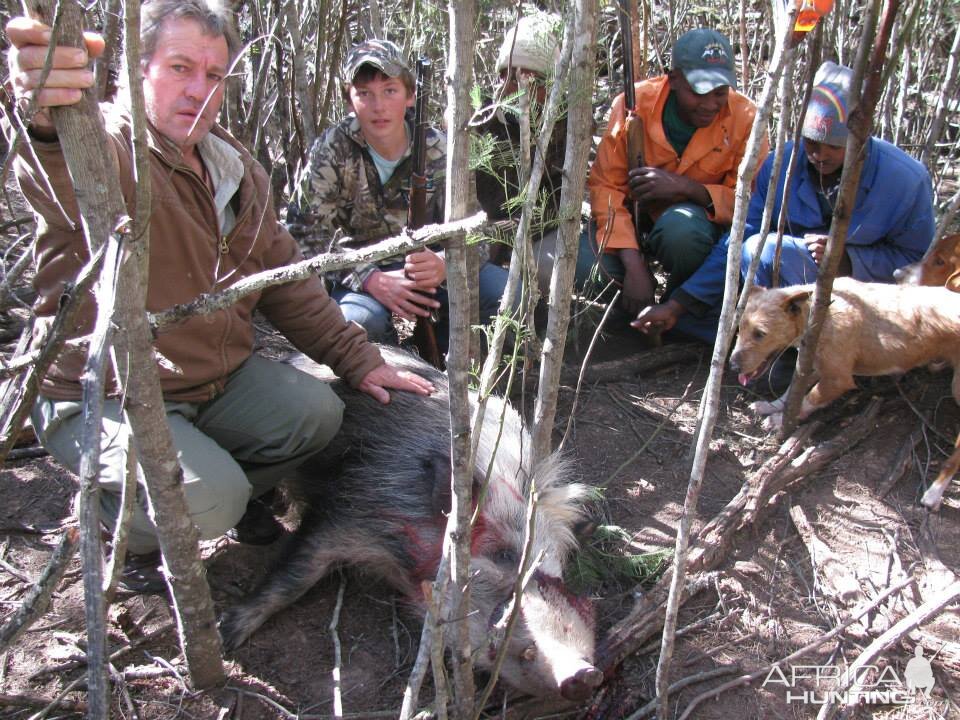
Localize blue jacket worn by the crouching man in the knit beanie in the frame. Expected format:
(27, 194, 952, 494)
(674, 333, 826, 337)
(674, 138, 934, 315)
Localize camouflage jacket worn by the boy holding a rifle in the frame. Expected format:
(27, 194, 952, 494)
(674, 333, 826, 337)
(287, 114, 447, 292)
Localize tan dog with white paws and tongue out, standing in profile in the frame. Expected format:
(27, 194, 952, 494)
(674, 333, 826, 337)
(730, 278, 960, 507)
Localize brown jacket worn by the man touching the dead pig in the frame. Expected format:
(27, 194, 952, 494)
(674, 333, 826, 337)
(16, 105, 383, 402)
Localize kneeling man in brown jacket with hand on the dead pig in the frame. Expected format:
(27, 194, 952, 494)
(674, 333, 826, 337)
(7, 0, 432, 592)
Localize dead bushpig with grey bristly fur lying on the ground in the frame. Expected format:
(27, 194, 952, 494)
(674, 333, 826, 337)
(220, 348, 603, 700)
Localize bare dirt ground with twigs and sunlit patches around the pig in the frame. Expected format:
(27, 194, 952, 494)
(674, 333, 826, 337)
(0, 306, 960, 720)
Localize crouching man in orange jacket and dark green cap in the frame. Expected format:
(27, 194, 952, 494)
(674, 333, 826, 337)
(581, 28, 767, 335)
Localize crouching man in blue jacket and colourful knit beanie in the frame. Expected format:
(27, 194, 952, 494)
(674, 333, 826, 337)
(633, 61, 934, 346)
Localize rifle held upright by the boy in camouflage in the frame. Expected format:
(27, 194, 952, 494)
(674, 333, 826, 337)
(407, 58, 444, 370)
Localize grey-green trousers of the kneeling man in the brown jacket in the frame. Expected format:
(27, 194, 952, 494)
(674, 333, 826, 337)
(33, 355, 343, 553)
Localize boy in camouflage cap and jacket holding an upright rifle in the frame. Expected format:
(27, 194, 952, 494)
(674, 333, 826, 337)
(287, 40, 507, 350)
